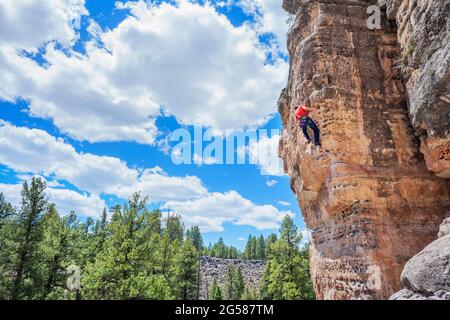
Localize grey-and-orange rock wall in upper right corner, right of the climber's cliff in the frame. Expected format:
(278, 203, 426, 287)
(385, 0, 450, 178)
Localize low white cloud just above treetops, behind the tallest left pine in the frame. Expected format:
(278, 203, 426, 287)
(0, 183, 106, 217)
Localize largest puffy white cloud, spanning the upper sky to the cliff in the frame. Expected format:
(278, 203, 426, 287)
(0, 0, 288, 143)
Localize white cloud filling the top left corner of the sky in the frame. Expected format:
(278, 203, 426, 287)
(0, 0, 87, 51)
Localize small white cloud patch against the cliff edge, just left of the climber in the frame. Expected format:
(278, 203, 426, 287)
(247, 134, 285, 176)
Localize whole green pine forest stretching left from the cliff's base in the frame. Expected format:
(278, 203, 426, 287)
(0, 178, 314, 300)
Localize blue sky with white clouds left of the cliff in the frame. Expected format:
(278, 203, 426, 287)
(0, 0, 304, 249)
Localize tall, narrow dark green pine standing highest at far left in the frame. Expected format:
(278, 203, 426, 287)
(10, 177, 47, 300)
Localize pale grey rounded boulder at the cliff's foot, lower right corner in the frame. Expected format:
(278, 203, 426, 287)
(390, 219, 450, 300)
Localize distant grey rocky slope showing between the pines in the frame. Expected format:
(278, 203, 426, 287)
(199, 257, 265, 300)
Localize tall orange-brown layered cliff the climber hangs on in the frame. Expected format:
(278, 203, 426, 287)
(278, 0, 450, 299)
